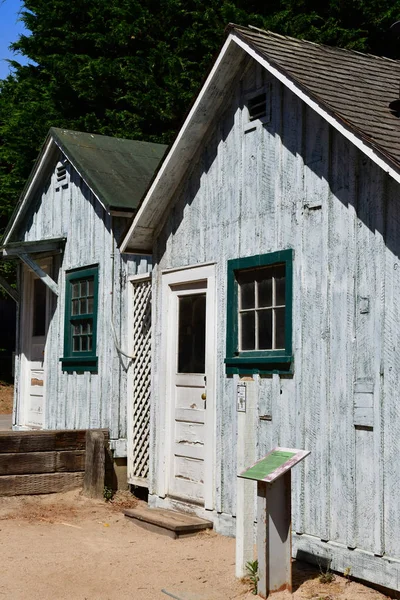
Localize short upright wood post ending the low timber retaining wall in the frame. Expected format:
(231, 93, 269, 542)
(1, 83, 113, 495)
(83, 429, 105, 498)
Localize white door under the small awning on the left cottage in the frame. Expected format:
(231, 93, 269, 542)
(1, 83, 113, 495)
(21, 264, 51, 428)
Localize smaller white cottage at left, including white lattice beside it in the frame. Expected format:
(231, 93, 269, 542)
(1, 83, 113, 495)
(1, 128, 166, 483)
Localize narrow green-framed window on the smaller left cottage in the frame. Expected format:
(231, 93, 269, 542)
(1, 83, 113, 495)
(61, 267, 98, 371)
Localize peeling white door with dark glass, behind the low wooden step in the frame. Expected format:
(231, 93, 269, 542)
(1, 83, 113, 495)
(167, 267, 215, 509)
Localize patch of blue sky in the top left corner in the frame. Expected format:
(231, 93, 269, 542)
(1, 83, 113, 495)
(0, 0, 26, 79)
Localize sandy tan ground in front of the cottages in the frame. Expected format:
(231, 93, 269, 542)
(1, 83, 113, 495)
(0, 492, 385, 600)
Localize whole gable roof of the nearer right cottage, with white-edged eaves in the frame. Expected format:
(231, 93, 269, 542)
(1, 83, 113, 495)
(121, 24, 400, 251)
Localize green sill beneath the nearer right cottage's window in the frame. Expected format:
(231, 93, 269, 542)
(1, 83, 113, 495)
(224, 353, 293, 375)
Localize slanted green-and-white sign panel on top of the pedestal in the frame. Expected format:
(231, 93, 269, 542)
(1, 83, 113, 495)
(238, 447, 310, 483)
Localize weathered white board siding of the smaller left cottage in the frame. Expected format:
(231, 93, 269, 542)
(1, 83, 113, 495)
(17, 165, 151, 448)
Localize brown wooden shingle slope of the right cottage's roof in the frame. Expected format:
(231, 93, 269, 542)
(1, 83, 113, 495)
(229, 25, 400, 166)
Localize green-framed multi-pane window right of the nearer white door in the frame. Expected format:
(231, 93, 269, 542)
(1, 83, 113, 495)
(225, 250, 293, 374)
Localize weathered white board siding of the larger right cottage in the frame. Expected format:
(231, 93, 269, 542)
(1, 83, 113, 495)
(151, 59, 400, 585)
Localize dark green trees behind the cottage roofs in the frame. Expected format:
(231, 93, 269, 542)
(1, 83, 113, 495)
(0, 0, 400, 233)
